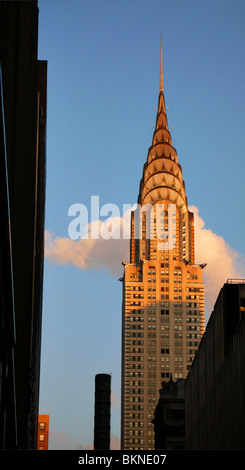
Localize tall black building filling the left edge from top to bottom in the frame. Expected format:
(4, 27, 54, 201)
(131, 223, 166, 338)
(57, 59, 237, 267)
(0, 0, 47, 449)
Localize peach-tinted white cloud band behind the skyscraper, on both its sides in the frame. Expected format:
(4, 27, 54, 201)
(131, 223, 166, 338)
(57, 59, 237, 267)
(45, 206, 245, 318)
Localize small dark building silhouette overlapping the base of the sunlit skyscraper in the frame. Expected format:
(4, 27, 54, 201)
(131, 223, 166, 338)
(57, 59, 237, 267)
(152, 377, 185, 450)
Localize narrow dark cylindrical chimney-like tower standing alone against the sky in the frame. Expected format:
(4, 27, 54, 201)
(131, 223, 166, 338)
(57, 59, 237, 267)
(94, 374, 111, 450)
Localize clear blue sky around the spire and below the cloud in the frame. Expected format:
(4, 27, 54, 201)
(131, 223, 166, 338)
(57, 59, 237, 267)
(38, 0, 245, 448)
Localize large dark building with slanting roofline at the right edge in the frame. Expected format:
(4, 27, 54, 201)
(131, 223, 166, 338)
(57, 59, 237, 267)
(185, 280, 245, 449)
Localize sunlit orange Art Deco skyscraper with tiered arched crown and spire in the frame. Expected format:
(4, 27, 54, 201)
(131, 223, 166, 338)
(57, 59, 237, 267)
(121, 45, 205, 450)
